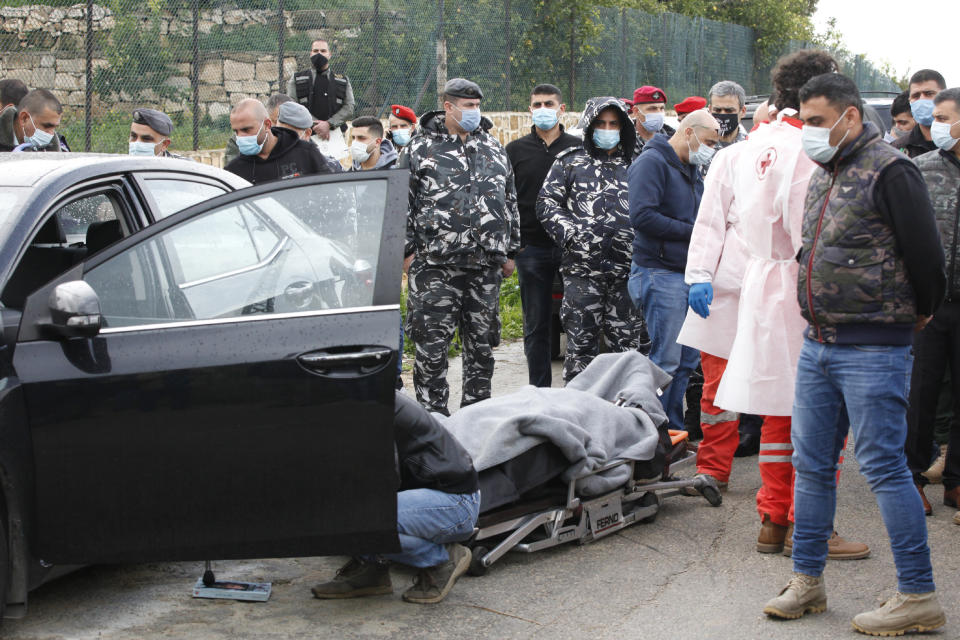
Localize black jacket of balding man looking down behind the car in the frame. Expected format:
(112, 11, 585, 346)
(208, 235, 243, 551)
(224, 127, 343, 184)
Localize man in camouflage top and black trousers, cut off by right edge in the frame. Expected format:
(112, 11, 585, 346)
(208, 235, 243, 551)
(906, 88, 960, 523)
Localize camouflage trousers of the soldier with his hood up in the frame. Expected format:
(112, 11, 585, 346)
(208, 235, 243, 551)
(560, 274, 641, 383)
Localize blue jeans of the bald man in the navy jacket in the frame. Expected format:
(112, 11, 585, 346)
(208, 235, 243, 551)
(627, 263, 700, 430)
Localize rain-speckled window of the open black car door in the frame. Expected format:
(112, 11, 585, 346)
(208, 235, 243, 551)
(84, 179, 387, 327)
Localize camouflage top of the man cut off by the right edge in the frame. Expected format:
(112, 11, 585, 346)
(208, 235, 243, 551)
(914, 150, 960, 302)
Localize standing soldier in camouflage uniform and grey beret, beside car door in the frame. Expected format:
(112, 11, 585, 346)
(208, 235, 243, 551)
(404, 78, 520, 414)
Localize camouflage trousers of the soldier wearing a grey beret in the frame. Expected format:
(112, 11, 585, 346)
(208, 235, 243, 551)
(406, 258, 502, 415)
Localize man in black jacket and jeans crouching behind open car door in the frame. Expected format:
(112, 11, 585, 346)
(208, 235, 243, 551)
(311, 393, 480, 604)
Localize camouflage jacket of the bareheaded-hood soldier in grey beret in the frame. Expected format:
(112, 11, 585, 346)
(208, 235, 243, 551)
(404, 111, 520, 268)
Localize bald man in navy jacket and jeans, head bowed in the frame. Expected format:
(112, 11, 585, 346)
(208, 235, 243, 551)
(627, 110, 720, 429)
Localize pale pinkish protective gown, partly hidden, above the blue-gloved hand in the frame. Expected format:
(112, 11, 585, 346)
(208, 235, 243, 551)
(677, 142, 748, 360)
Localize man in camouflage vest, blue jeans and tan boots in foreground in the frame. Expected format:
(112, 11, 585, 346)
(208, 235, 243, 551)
(764, 73, 946, 636)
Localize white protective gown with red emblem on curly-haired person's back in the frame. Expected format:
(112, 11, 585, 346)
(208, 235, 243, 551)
(714, 110, 816, 416)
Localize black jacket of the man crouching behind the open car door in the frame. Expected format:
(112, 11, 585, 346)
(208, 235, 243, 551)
(393, 392, 480, 493)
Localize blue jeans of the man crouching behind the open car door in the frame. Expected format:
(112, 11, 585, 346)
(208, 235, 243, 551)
(368, 489, 480, 569)
